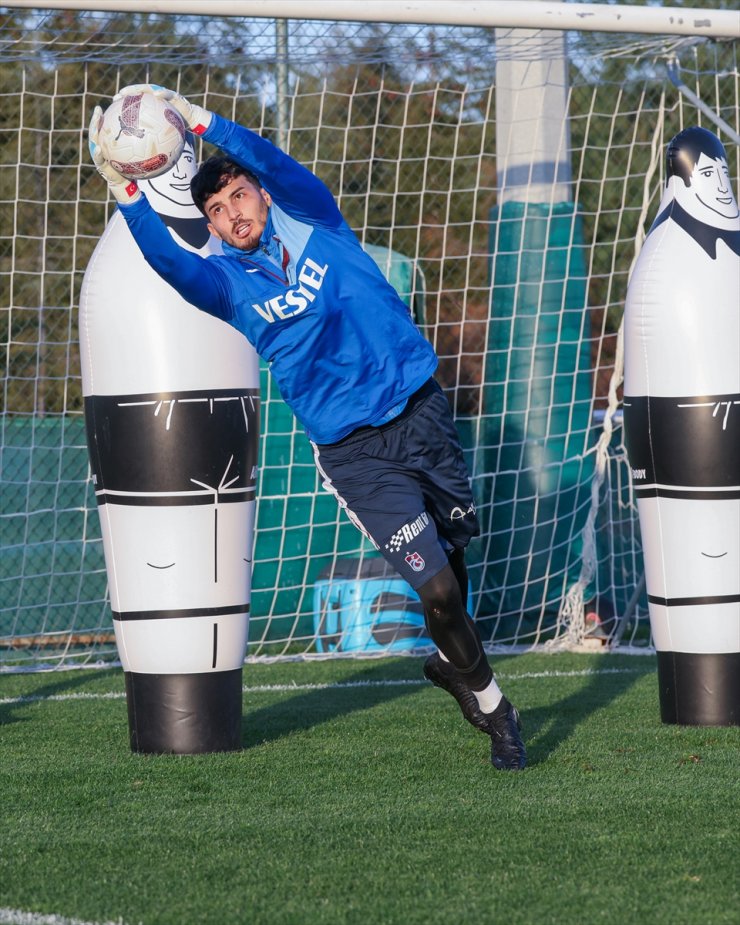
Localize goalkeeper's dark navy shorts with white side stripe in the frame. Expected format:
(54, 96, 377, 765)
(313, 379, 480, 589)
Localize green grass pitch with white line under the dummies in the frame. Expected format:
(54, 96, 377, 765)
(0, 654, 740, 925)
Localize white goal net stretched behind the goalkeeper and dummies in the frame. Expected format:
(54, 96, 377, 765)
(0, 4, 740, 667)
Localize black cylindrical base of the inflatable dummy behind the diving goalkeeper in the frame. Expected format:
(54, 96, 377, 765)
(124, 668, 242, 755)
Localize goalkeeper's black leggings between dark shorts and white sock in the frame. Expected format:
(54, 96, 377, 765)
(417, 549, 493, 691)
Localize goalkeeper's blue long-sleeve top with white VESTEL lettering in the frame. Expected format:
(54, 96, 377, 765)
(120, 115, 437, 443)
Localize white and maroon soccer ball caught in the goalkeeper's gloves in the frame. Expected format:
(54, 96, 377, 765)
(98, 93, 187, 180)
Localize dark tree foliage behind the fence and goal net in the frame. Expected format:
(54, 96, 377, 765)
(0, 3, 739, 413)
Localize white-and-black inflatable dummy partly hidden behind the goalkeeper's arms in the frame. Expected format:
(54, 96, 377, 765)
(80, 134, 259, 754)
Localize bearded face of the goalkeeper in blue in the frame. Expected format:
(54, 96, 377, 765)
(205, 177, 270, 251)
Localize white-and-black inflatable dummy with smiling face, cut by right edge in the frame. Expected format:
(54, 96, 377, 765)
(624, 128, 740, 725)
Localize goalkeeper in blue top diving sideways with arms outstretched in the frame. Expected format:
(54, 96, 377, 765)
(89, 84, 526, 770)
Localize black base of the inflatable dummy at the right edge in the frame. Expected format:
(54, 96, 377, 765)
(658, 652, 740, 726)
